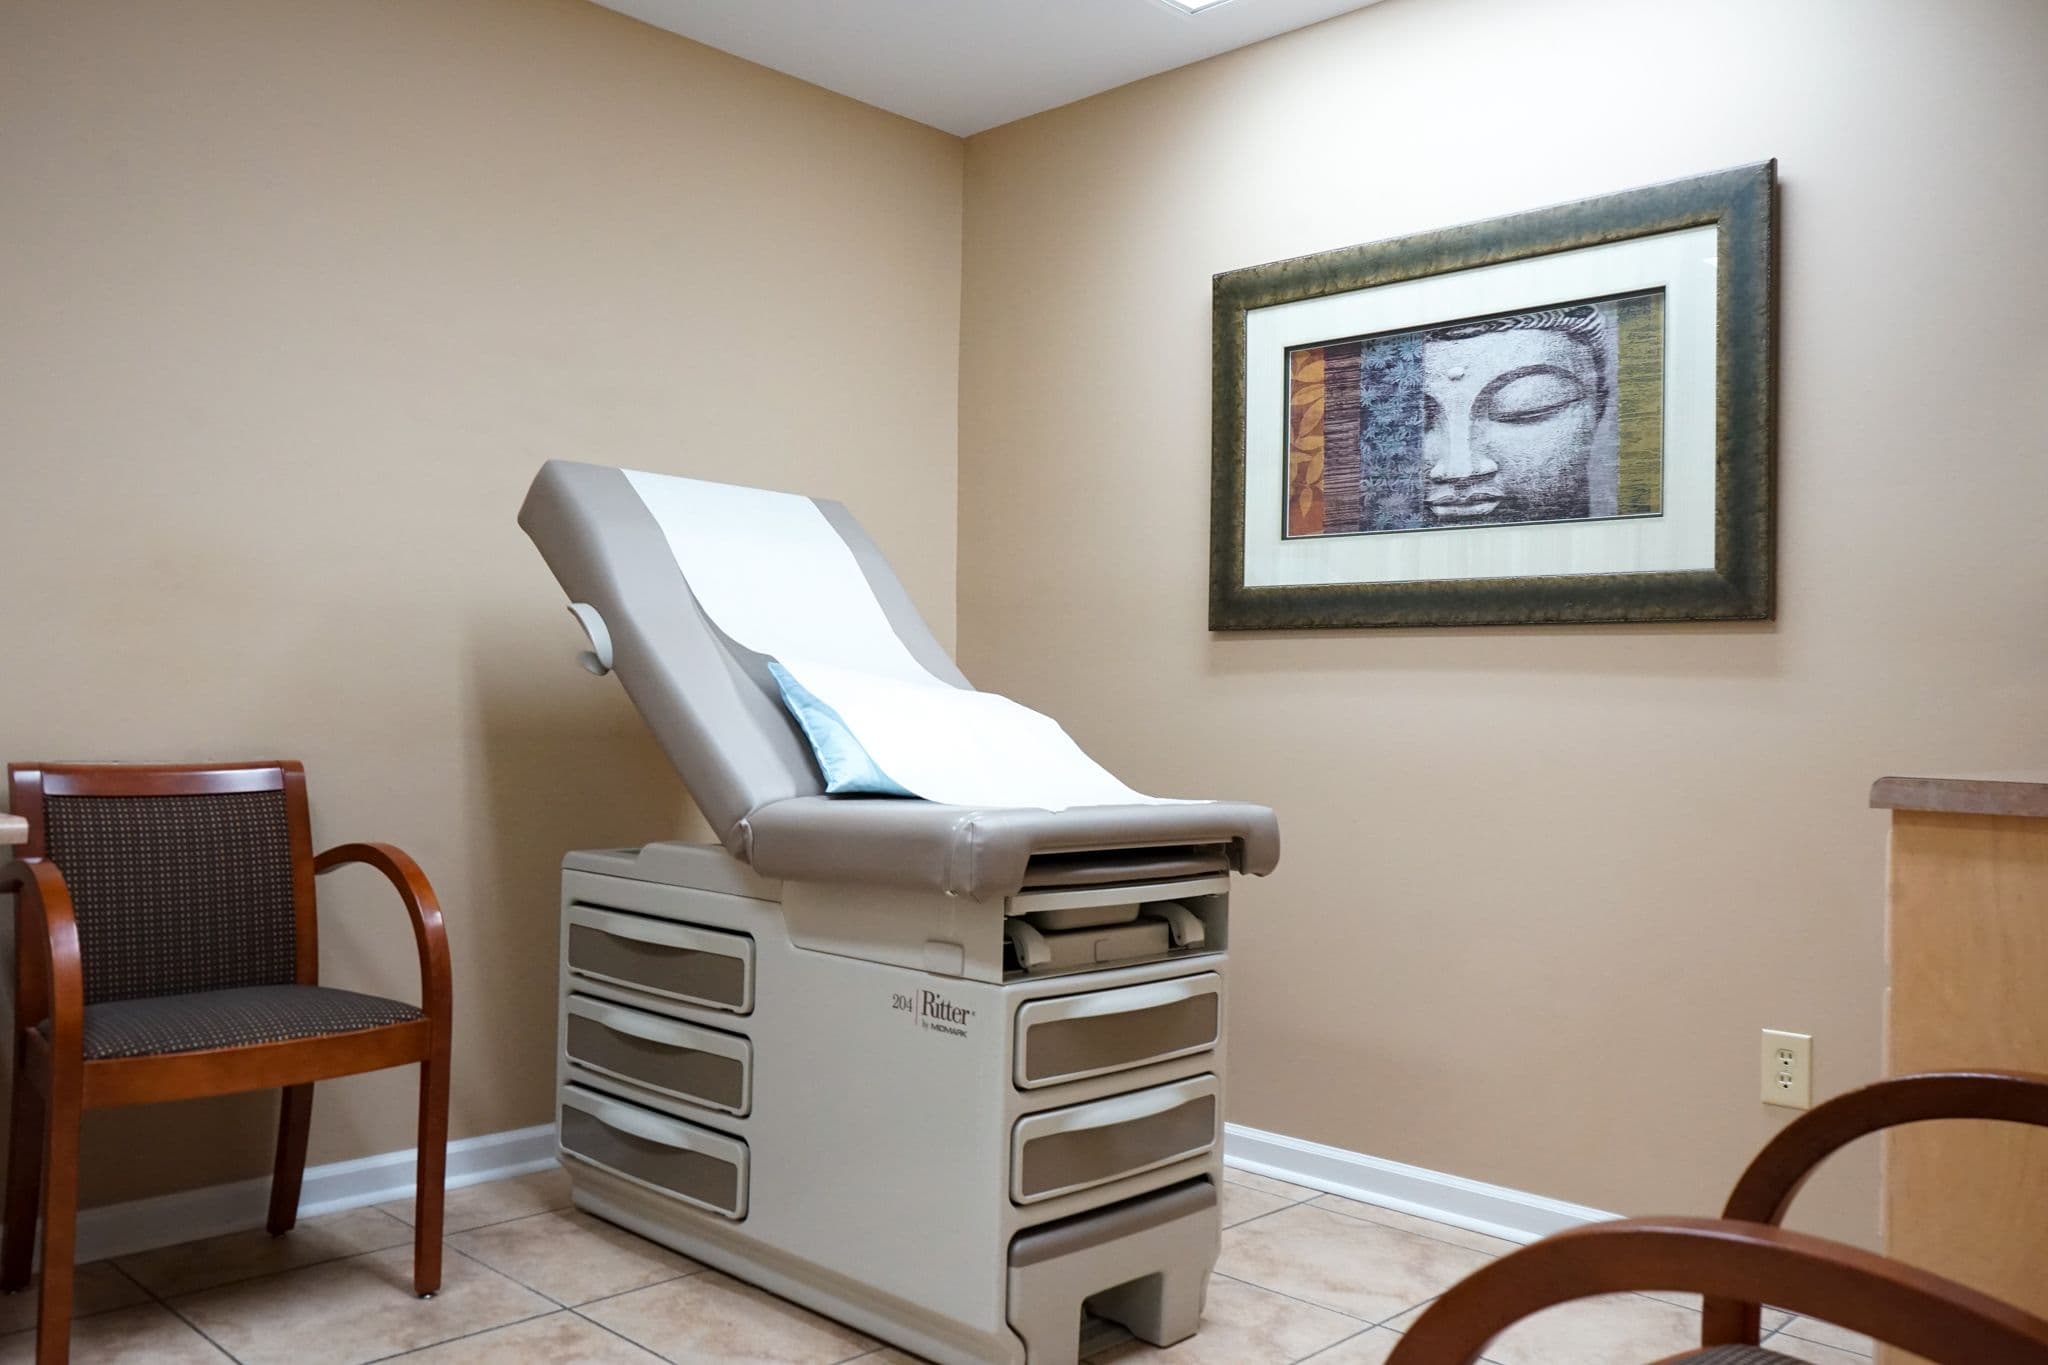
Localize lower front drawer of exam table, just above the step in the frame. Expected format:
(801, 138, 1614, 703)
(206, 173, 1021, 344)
(1010, 1074, 1221, 1203)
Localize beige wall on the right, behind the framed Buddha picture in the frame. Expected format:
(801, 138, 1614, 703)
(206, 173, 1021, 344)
(961, 0, 2048, 1236)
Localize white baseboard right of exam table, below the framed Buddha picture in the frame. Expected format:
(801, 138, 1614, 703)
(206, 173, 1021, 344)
(1223, 1124, 1620, 1242)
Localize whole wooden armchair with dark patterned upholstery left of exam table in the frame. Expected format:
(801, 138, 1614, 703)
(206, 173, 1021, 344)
(0, 761, 451, 1365)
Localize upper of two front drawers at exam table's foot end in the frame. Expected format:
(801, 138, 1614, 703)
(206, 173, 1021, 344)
(1016, 972, 1223, 1091)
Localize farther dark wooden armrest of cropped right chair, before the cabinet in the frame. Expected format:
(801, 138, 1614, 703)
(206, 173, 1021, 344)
(1704, 1070, 2048, 1345)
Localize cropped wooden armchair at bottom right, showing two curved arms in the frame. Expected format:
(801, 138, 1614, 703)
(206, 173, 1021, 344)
(1389, 1072, 2048, 1365)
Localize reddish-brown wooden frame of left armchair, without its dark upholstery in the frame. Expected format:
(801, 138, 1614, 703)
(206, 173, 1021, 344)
(0, 759, 453, 1365)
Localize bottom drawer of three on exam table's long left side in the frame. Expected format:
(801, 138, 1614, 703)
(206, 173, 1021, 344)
(561, 1085, 748, 1218)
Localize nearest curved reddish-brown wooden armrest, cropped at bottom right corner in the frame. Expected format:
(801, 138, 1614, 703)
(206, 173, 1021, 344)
(1386, 1218, 2048, 1365)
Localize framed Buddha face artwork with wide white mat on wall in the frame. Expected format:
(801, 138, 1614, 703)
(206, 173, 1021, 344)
(1208, 162, 1776, 630)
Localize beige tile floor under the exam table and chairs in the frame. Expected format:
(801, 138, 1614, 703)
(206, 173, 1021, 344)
(0, 1171, 1870, 1365)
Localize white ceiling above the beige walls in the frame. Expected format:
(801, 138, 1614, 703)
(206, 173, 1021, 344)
(596, 0, 1372, 137)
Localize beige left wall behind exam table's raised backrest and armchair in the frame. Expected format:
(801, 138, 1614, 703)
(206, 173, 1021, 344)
(0, 0, 963, 1201)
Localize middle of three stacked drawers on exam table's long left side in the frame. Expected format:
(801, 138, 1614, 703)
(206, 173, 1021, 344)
(563, 995, 754, 1117)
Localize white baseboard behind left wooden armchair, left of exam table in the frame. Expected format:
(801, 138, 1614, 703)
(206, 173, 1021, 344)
(78, 1124, 555, 1265)
